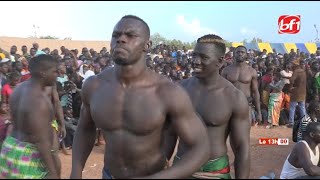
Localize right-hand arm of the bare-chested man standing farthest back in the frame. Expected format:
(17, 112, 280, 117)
(251, 69, 262, 121)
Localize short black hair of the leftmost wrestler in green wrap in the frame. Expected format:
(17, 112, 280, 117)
(29, 54, 58, 76)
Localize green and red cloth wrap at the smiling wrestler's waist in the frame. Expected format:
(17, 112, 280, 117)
(175, 155, 231, 179)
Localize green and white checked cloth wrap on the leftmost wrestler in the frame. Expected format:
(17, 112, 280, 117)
(0, 136, 48, 179)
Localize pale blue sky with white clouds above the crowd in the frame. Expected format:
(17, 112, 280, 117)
(0, 1, 320, 43)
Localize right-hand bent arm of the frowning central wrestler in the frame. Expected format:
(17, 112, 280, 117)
(144, 85, 210, 179)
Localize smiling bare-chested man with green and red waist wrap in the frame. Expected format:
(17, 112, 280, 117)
(174, 34, 250, 179)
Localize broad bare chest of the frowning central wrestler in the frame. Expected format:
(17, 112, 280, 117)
(90, 84, 165, 135)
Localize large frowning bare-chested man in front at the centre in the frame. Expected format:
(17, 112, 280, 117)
(71, 15, 209, 179)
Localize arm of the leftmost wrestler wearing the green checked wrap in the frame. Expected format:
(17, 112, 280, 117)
(25, 97, 59, 178)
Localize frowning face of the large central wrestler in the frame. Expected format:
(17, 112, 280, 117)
(111, 18, 148, 66)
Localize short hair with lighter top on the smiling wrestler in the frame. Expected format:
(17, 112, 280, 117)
(197, 34, 226, 55)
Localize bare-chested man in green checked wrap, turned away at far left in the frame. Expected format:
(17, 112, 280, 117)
(0, 55, 60, 179)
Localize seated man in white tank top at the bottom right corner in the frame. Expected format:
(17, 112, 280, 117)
(280, 122, 320, 179)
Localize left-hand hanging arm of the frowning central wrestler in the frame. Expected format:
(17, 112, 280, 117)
(71, 77, 96, 179)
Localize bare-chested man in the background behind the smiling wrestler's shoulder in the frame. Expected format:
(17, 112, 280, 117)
(221, 46, 262, 124)
